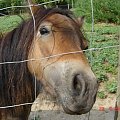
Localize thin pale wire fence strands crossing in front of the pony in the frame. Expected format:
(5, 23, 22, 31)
(0, 0, 119, 120)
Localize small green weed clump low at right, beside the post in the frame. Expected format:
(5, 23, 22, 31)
(106, 81, 117, 93)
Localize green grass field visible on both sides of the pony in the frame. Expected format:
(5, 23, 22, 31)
(0, 15, 120, 98)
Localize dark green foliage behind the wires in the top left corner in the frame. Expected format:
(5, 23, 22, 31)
(0, 0, 68, 14)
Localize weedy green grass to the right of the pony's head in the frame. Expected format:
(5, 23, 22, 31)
(84, 24, 119, 82)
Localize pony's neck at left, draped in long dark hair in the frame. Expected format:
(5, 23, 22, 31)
(0, 24, 39, 120)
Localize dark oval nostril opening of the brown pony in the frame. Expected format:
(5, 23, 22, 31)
(73, 75, 82, 95)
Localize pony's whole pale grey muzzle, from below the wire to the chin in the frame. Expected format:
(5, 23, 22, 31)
(44, 62, 98, 115)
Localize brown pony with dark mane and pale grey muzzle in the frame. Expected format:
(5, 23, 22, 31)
(0, 8, 98, 120)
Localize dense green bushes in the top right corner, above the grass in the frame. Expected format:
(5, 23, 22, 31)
(75, 0, 120, 24)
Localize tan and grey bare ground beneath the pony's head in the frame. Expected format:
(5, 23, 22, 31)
(29, 91, 116, 120)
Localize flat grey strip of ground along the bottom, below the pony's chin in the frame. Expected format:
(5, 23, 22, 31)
(31, 110, 114, 120)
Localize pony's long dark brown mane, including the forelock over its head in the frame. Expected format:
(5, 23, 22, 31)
(0, 8, 76, 114)
